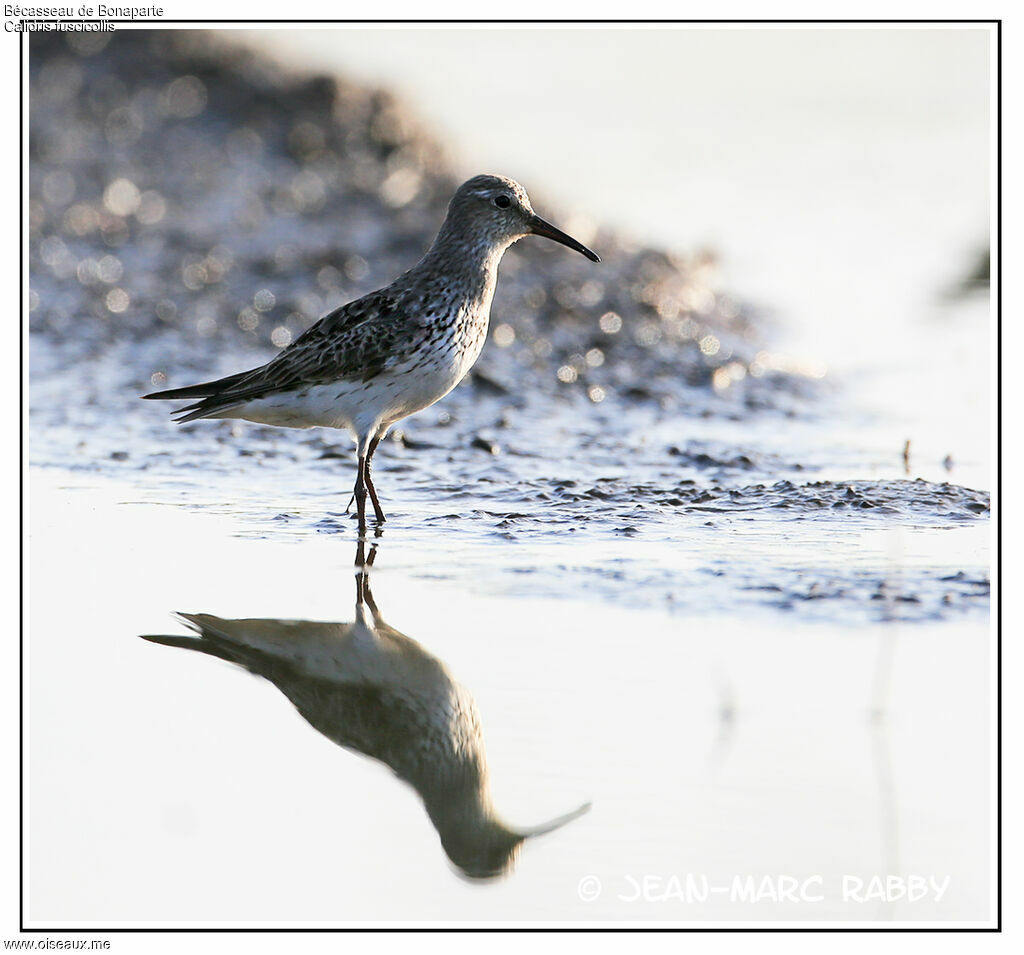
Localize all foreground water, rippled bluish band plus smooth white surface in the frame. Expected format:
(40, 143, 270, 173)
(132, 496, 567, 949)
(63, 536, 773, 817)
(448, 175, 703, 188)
(29, 315, 992, 924)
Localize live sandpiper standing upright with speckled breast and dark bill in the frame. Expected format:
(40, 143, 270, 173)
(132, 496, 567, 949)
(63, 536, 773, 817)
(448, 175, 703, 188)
(143, 176, 601, 529)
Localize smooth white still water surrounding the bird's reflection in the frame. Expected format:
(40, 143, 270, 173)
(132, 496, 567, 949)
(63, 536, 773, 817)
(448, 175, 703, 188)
(29, 473, 991, 924)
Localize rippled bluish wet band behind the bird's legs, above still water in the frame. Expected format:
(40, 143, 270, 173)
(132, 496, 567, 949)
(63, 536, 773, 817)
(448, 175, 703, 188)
(31, 317, 989, 625)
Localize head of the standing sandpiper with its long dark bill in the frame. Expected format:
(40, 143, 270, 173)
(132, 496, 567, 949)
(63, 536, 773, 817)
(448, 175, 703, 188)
(445, 176, 601, 262)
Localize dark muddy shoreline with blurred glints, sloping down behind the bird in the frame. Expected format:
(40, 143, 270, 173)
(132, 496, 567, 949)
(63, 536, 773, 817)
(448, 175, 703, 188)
(30, 31, 990, 622)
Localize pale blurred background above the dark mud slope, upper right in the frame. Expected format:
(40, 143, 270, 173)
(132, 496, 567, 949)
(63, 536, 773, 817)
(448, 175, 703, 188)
(239, 26, 993, 481)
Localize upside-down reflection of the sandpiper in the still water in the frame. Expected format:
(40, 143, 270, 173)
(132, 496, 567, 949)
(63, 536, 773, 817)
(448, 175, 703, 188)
(142, 540, 590, 879)
